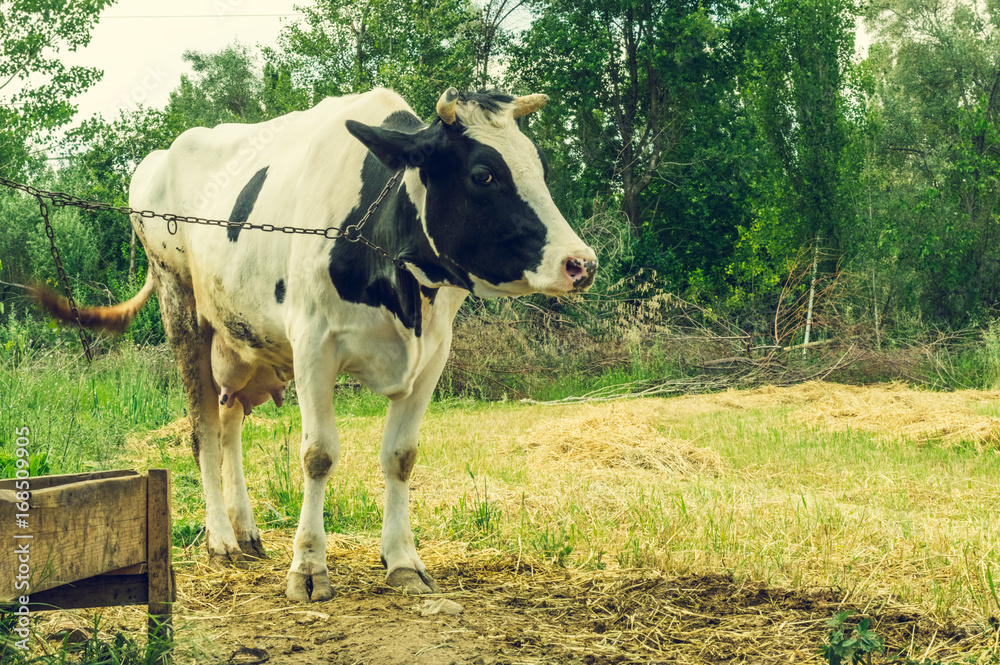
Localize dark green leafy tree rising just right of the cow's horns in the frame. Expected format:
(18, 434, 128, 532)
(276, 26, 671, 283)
(511, 0, 722, 236)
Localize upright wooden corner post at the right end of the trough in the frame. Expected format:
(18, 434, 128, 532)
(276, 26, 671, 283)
(146, 469, 177, 662)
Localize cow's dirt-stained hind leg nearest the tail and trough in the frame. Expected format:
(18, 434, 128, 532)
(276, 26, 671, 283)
(158, 266, 245, 565)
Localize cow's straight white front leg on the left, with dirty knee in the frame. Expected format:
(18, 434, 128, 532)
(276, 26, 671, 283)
(285, 338, 340, 602)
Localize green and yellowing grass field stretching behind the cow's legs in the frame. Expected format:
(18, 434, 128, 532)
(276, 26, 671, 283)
(0, 350, 1000, 654)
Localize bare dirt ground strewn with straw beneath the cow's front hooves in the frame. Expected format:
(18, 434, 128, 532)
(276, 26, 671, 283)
(125, 536, 990, 665)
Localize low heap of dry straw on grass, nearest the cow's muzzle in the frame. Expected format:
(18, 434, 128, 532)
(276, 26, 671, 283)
(523, 400, 722, 476)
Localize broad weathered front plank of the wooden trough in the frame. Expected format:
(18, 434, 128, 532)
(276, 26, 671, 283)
(0, 473, 147, 601)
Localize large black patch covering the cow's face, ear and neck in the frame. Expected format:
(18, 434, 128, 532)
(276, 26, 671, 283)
(342, 96, 548, 304)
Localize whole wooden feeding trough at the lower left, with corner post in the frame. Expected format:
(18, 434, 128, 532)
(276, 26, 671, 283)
(0, 469, 176, 642)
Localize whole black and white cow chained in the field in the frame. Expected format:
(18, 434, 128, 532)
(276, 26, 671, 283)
(39, 88, 597, 601)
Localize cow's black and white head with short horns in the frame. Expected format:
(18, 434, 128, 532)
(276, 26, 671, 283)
(347, 88, 597, 297)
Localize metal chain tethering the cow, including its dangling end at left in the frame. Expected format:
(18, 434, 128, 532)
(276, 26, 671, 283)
(0, 169, 406, 362)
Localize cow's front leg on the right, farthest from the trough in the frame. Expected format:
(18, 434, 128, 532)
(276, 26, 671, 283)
(379, 343, 450, 593)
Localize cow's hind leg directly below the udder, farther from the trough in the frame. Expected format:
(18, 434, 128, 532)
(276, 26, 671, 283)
(219, 406, 267, 559)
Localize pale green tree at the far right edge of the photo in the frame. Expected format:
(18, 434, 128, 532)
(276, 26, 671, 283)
(867, 0, 1000, 324)
